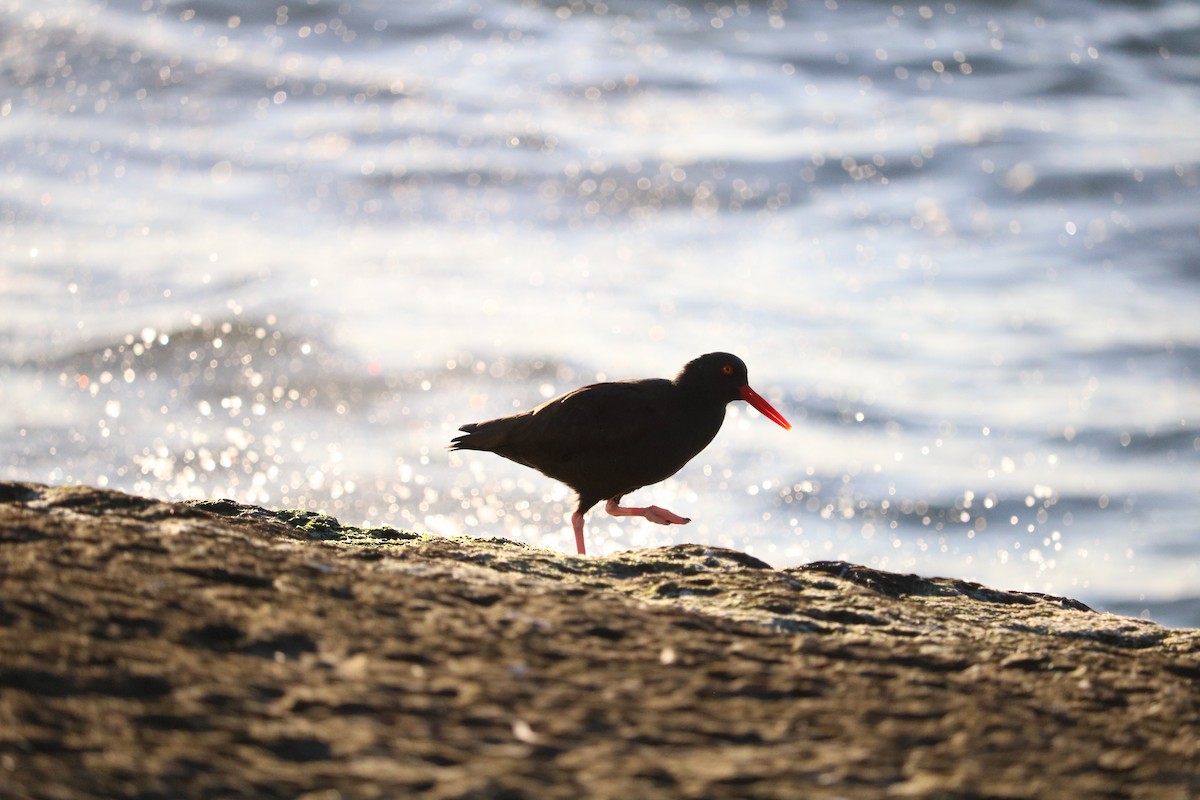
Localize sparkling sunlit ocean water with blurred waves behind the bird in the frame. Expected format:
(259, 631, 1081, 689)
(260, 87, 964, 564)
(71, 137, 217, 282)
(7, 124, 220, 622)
(0, 0, 1200, 626)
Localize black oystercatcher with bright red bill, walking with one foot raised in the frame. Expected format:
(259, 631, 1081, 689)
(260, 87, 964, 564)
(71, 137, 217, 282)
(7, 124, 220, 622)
(450, 353, 792, 555)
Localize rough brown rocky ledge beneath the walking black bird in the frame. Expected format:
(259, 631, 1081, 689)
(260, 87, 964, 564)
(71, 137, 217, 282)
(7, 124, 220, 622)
(0, 482, 1200, 800)
